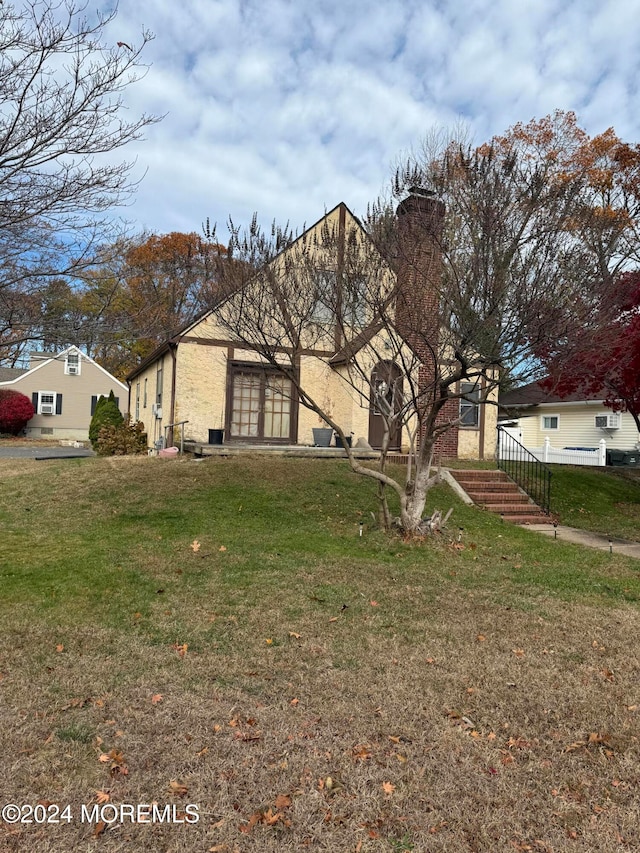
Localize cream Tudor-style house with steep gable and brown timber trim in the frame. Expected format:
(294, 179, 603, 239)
(127, 196, 497, 459)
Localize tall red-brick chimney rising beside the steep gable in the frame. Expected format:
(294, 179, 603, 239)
(396, 187, 459, 457)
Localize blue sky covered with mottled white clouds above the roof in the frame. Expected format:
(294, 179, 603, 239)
(101, 0, 640, 237)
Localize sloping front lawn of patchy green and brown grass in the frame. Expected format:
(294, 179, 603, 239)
(0, 460, 640, 853)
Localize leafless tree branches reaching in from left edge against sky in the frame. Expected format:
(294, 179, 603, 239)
(0, 0, 157, 360)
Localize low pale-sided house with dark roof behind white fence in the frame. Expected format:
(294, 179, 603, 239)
(500, 382, 640, 450)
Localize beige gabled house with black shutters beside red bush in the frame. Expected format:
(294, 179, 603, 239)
(0, 346, 128, 441)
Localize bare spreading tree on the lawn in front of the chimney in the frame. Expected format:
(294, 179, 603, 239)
(202, 115, 624, 533)
